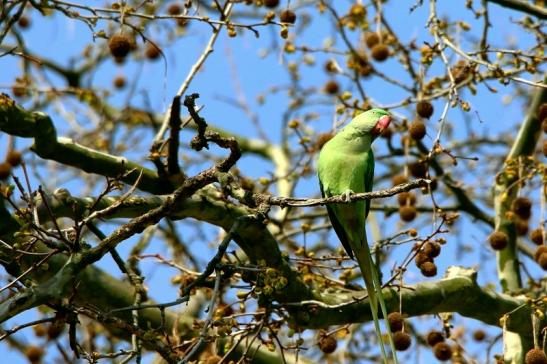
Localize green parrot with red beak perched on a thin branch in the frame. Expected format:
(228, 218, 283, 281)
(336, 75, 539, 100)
(317, 109, 397, 363)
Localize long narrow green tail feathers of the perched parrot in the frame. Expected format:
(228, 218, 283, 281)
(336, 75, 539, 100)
(354, 236, 397, 364)
